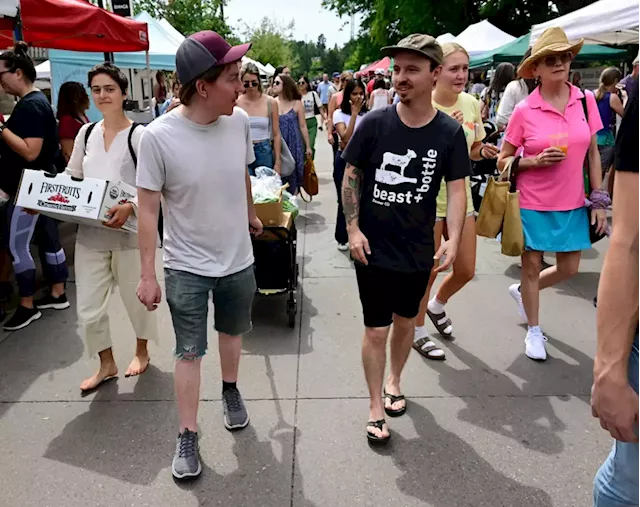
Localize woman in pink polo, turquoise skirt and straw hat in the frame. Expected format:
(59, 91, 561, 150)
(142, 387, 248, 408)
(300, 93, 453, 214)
(498, 28, 610, 361)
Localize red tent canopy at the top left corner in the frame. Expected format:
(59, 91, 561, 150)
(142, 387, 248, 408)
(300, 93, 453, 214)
(0, 0, 149, 53)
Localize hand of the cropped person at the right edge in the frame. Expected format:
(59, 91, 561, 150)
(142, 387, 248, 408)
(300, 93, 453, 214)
(591, 377, 640, 443)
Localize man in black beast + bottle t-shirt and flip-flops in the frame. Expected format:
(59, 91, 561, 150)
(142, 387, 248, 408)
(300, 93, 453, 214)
(342, 34, 471, 442)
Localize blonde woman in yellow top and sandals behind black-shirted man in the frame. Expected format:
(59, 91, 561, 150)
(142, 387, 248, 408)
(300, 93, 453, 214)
(414, 43, 499, 360)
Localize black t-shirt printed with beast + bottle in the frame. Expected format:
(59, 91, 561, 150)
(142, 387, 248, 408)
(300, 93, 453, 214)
(342, 106, 471, 273)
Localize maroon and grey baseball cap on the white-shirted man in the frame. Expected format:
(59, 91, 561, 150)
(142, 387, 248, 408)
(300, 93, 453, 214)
(176, 30, 251, 84)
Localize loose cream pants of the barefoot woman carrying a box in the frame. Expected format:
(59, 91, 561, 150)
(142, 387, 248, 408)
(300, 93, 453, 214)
(75, 243, 158, 357)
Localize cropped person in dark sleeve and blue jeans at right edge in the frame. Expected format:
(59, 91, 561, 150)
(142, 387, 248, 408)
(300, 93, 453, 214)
(591, 82, 640, 507)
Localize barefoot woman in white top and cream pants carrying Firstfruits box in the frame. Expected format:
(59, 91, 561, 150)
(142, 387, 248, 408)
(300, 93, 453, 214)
(67, 63, 158, 391)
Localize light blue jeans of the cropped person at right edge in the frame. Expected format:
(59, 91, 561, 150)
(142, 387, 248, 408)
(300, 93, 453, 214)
(593, 331, 640, 507)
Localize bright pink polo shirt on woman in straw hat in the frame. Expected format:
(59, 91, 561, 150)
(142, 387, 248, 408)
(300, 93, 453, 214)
(505, 83, 602, 211)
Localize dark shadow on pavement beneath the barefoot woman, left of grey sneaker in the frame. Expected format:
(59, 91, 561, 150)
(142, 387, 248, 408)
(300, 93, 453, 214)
(44, 364, 176, 485)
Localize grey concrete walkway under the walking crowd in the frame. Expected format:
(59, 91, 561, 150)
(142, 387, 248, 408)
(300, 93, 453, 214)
(0, 133, 610, 507)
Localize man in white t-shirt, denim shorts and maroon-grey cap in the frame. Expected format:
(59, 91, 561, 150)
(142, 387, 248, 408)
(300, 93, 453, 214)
(137, 31, 262, 479)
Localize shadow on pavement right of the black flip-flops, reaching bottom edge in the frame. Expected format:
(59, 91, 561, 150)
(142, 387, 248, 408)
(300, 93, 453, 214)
(390, 402, 553, 507)
